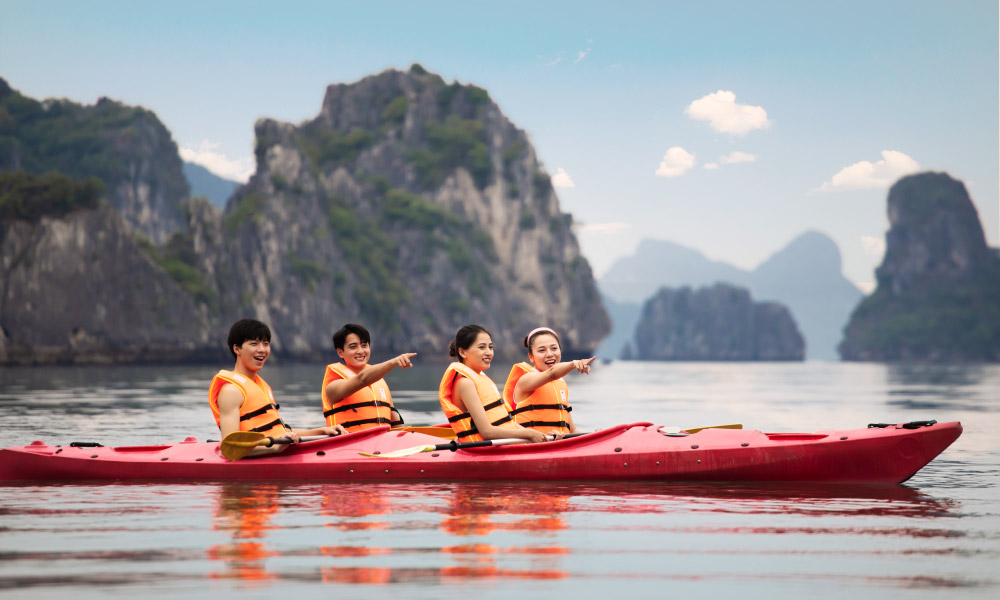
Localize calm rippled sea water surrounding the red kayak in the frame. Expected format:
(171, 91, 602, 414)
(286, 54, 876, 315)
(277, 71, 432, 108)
(0, 362, 1000, 600)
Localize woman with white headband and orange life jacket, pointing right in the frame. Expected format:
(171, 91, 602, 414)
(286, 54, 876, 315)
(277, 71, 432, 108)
(503, 327, 596, 434)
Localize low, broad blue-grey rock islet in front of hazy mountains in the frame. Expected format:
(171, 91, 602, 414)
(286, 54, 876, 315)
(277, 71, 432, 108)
(627, 284, 805, 361)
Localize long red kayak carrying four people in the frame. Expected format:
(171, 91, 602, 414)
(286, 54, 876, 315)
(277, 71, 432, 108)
(0, 421, 962, 483)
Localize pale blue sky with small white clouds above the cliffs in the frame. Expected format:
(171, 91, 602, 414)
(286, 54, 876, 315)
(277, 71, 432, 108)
(0, 0, 1000, 289)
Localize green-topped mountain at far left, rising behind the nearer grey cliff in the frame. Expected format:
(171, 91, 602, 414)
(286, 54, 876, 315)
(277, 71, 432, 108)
(0, 79, 189, 243)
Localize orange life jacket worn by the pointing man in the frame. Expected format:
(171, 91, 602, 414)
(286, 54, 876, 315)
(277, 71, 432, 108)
(322, 363, 403, 431)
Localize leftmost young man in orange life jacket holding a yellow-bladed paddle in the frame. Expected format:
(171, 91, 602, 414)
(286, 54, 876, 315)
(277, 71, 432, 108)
(208, 319, 347, 456)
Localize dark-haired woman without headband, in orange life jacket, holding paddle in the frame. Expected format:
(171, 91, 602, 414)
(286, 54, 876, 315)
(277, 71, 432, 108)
(438, 325, 545, 442)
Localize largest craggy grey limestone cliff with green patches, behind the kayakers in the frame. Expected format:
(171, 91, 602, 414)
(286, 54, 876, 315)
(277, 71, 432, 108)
(195, 66, 610, 356)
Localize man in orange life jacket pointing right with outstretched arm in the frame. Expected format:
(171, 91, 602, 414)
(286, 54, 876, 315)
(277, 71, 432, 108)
(322, 323, 416, 431)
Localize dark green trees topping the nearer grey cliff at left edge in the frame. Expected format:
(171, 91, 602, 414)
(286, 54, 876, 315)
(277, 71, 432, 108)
(0, 170, 104, 221)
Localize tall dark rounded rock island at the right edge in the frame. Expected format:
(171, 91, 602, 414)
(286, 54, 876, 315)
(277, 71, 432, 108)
(840, 173, 1000, 362)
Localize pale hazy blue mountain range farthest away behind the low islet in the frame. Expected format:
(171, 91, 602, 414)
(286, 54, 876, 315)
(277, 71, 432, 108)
(598, 231, 864, 360)
